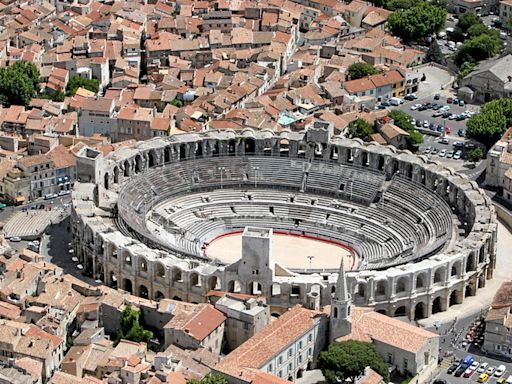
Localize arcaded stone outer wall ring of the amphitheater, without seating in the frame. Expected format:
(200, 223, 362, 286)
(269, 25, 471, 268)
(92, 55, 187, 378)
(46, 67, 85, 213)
(71, 129, 497, 319)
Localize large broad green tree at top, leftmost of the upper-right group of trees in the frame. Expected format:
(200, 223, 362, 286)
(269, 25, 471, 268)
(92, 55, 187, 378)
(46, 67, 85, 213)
(388, 2, 446, 43)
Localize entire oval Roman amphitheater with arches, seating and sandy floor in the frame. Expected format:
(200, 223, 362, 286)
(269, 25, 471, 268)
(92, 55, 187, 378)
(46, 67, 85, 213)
(72, 125, 497, 319)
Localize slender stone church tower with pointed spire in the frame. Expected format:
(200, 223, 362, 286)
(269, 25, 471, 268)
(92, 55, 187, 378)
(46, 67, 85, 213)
(330, 260, 352, 342)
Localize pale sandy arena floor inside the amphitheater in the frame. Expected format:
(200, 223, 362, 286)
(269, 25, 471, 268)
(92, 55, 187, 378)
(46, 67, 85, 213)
(206, 233, 355, 270)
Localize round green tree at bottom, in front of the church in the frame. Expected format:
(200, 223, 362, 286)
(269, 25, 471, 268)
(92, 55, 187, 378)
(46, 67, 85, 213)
(318, 340, 389, 383)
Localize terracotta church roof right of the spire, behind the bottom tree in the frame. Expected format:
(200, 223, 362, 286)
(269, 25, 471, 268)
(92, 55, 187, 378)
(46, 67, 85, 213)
(337, 307, 439, 353)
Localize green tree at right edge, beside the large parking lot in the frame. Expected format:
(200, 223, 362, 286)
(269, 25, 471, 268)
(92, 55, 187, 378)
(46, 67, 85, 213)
(466, 98, 512, 148)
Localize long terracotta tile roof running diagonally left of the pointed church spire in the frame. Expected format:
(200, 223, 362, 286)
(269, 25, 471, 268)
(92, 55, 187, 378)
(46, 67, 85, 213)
(215, 305, 326, 382)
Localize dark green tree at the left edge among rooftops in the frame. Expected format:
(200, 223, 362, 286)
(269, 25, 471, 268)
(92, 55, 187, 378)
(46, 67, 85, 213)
(0, 61, 39, 107)
